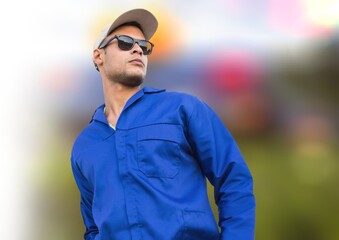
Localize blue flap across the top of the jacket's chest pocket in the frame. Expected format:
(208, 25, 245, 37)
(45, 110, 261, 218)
(138, 124, 182, 143)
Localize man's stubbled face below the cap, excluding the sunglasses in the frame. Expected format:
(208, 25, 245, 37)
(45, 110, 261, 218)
(99, 26, 148, 87)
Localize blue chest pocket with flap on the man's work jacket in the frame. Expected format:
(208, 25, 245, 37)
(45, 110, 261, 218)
(137, 124, 182, 178)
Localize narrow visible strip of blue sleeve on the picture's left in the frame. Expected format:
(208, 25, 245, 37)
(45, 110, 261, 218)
(71, 155, 98, 240)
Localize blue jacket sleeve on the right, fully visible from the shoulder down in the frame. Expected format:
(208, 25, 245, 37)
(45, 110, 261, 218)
(188, 98, 255, 240)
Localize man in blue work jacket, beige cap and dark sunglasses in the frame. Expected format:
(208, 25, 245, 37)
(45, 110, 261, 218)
(71, 9, 255, 240)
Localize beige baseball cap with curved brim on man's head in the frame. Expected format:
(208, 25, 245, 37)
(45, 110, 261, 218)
(93, 8, 158, 50)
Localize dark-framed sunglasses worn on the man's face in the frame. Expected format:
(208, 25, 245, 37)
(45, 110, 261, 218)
(99, 35, 154, 55)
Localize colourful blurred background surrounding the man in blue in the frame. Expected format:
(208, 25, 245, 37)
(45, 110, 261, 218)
(0, 0, 339, 240)
